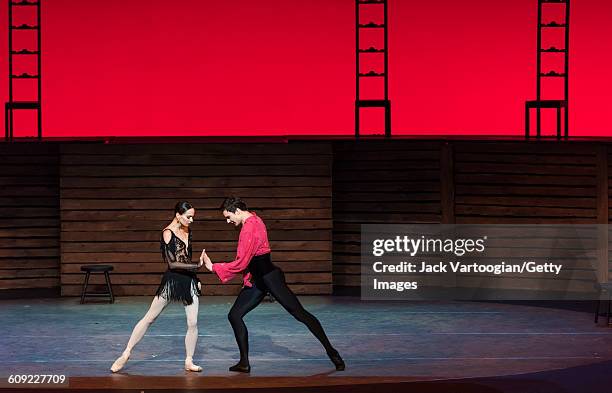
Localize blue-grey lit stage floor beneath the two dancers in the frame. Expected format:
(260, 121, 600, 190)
(0, 296, 612, 391)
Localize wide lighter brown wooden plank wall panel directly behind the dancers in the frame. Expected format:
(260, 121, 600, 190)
(61, 142, 332, 296)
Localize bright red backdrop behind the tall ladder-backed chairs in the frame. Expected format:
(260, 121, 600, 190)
(0, 0, 612, 136)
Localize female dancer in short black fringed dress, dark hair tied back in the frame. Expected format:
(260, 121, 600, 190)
(111, 201, 203, 373)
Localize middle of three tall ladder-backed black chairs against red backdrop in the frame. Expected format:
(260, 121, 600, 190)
(355, 0, 391, 138)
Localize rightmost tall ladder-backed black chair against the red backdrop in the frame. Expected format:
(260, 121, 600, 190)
(525, 0, 570, 139)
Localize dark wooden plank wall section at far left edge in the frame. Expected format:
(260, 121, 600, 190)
(0, 143, 60, 290)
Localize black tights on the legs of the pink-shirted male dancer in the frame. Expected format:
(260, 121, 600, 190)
(228, 269, 336, 364)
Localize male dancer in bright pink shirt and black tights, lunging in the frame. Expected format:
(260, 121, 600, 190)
(202, 197, 345, 373)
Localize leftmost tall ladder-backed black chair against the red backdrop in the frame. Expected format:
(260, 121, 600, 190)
(4, 0, 42, 141)
